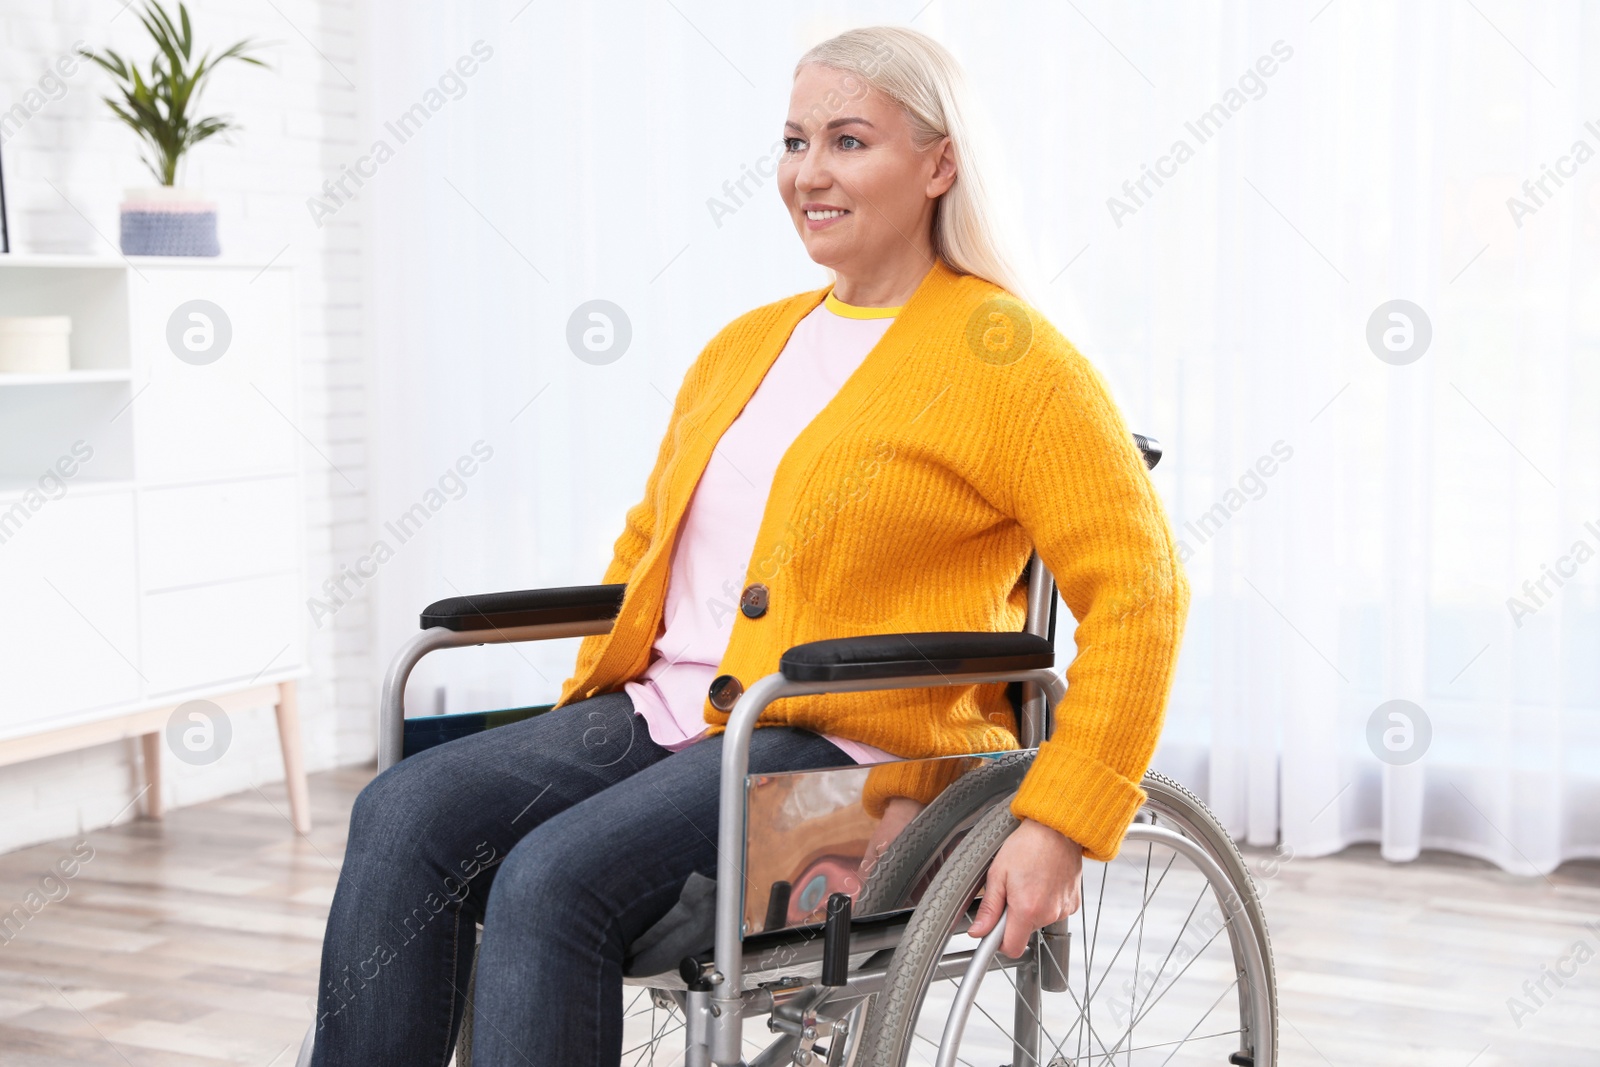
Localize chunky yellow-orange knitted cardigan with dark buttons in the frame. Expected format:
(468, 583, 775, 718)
(557, 262, 1189, 859)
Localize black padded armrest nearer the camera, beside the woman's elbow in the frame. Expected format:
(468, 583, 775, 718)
(778, 632, 1056, 681)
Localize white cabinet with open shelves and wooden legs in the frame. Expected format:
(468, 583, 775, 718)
(0, 254, 309, 832)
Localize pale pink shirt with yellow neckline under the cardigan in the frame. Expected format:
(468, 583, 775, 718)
(622, 291, 899, 763)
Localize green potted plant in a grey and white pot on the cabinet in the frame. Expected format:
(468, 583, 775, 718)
(80, 0, 267, 256)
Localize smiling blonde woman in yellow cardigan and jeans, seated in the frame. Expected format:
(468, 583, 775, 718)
(314, 27, 1189, 1067)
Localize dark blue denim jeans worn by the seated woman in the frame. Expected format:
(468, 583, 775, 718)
(312, 693, 851, 1067)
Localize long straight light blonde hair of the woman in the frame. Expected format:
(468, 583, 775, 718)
(795, 26, 1032, 302)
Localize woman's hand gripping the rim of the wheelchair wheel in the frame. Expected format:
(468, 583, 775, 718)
(966, 819, 1083, 960)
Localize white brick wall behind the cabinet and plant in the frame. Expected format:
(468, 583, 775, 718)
(0, 0, 376, 849)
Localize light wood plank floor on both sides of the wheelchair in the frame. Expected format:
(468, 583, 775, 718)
(0, 769, 1600, 1067)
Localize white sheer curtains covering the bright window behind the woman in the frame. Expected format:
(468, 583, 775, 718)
(363, 0, 1600, 873)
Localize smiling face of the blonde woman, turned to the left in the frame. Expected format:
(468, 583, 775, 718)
(778, 64, 955, 277)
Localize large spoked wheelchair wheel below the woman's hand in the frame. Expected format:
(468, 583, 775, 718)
(859, 774, 1277, 1067)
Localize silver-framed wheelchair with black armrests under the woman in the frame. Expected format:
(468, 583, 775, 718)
(299, 434, 1278, 1067)
